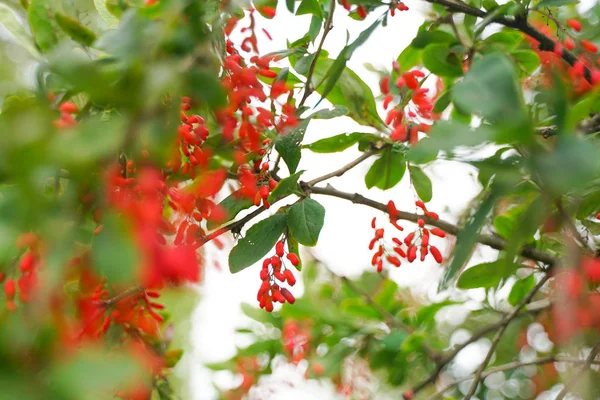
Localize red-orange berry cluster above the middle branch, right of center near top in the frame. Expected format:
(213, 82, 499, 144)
(379, 62, 442, 145)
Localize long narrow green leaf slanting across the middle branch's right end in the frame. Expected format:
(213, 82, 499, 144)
(440, 187, 499, 288)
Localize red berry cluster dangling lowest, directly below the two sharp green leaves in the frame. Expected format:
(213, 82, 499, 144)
(257, 239, 300, 312)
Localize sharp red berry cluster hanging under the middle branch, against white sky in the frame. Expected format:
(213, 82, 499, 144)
(369, 200, 446, 272)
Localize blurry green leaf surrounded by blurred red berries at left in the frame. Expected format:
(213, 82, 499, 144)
(92, 214, 141, 284)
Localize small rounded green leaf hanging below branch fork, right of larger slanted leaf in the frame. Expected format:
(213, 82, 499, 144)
(287, 198, 325, 246)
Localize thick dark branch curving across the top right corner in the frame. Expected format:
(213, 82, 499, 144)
(425, 0, 592, 83)
